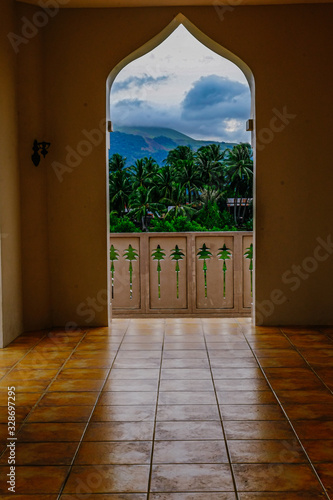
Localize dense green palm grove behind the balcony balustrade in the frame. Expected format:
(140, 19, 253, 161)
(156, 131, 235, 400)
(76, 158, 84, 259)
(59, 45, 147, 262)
(109, 144, 253, 232)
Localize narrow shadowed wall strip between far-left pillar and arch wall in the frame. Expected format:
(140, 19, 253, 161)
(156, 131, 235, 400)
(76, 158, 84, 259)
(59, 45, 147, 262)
(16, 3, 52, 331)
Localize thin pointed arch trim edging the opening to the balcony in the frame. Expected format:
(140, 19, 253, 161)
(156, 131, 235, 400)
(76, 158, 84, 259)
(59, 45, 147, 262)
(106, 13, 256, 324)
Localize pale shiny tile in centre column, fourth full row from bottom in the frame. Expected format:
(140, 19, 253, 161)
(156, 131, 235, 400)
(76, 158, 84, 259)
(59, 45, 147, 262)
(156, 404, 220, 422)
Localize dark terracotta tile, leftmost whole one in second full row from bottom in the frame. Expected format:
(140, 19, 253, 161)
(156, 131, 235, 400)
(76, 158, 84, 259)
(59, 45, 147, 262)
(0, 442, 78, 466)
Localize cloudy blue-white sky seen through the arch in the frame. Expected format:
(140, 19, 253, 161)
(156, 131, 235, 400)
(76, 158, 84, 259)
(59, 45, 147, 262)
(111, 25, 250, 142)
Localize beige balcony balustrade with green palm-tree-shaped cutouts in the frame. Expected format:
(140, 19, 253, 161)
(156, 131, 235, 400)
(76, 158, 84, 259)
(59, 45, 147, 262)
(110, 232, 253, 317)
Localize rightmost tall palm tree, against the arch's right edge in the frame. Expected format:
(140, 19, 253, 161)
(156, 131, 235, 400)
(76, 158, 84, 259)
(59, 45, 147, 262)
(225, 144, 253, 224)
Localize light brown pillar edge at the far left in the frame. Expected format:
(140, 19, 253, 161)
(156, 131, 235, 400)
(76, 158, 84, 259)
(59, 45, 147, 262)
(0, 0, 22, 347)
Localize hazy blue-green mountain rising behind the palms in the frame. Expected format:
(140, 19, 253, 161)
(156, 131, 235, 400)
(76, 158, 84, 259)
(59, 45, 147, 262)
(109, 127, 236, 165)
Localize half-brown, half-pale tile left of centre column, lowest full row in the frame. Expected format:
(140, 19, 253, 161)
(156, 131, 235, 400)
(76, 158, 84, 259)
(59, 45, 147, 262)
(64, 465, 149, 493)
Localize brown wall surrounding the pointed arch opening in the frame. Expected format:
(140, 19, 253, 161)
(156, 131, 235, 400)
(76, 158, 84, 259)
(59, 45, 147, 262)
(14, 5, 333, 326)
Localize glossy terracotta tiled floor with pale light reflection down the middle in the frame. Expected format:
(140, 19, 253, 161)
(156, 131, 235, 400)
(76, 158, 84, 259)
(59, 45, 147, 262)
(0, 318, 333, 500)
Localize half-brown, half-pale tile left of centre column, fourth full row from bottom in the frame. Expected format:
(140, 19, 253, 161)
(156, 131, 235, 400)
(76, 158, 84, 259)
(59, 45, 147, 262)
(91, 405, 155, 422)
